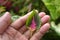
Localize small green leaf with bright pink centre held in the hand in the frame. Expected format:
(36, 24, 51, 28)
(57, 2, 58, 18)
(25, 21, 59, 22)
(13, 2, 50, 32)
(26, 9, 41, 32)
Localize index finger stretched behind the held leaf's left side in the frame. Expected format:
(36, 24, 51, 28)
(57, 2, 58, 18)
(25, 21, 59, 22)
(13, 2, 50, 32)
(11, 12, 31, 29)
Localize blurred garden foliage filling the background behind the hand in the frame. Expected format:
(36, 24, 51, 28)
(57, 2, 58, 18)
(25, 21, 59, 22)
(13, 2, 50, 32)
(0, 0, 60, 40)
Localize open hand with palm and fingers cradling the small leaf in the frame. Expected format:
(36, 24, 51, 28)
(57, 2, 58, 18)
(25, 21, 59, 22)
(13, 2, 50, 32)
(0, 12, 50, 40)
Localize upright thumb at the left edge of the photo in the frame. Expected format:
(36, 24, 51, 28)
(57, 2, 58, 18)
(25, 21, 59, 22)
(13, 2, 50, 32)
(0, 12, 11, 34)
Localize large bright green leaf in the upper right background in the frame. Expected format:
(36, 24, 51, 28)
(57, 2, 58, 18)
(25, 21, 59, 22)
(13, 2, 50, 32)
(43, 0, 60, 20)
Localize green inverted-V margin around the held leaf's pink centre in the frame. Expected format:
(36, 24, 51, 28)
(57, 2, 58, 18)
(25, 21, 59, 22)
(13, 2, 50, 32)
(26, 10, 41, 29)
